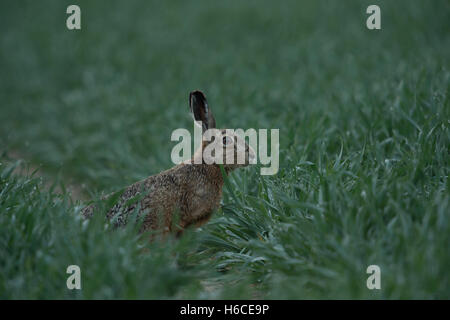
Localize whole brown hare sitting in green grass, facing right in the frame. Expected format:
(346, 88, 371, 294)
(82, 91, 256, 236)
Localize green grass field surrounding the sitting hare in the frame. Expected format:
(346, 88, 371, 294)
(0, 1, 450, 299)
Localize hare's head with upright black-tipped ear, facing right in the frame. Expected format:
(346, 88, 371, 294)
(189, 91, 256, 171)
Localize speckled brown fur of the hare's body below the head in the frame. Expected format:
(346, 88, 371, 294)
(83, 144, 223, 234)
